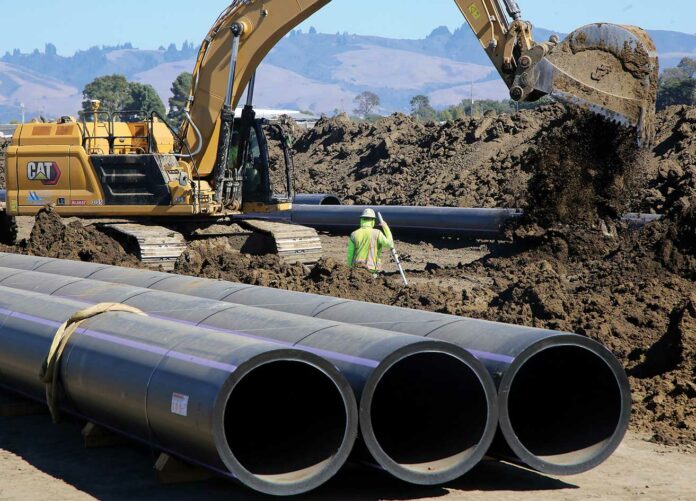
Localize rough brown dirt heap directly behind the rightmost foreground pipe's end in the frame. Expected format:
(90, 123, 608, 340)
(454, 226, 696, 444)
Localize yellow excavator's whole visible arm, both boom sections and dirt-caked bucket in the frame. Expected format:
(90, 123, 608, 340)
(182, 0, 658, 184)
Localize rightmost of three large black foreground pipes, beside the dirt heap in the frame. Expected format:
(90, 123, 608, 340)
(0, 254, 631, 475)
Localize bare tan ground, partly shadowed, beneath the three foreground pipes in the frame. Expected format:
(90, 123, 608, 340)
(0, 395, 696, 501)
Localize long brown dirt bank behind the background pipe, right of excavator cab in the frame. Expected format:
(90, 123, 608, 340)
(294, 105, 568, 207)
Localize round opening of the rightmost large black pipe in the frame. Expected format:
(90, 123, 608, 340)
(508, 346, 622, 465)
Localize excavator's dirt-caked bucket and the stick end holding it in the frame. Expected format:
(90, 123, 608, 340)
(455, 0, 659, 143)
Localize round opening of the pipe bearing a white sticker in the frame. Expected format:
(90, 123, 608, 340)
(225, 360, 348, 484)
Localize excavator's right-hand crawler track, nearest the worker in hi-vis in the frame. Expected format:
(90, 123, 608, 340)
(240, 220, 322, 265)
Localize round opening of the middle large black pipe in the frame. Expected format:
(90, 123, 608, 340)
(371, 353, 488, 473)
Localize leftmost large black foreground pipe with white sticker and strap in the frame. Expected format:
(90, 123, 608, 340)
(0, 287, 357, 495)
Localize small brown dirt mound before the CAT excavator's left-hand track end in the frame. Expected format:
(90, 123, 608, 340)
(22, 207, 139, 266)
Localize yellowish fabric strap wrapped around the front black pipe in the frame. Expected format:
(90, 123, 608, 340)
(39, 303, 147, 423)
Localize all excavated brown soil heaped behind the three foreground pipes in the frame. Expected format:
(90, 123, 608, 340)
(1, 106, 696, 452)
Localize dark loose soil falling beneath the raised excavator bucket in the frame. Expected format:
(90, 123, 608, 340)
(523, 113, 653, 226)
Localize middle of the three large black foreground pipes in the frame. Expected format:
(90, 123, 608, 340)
(0, 255, 497, 485)
